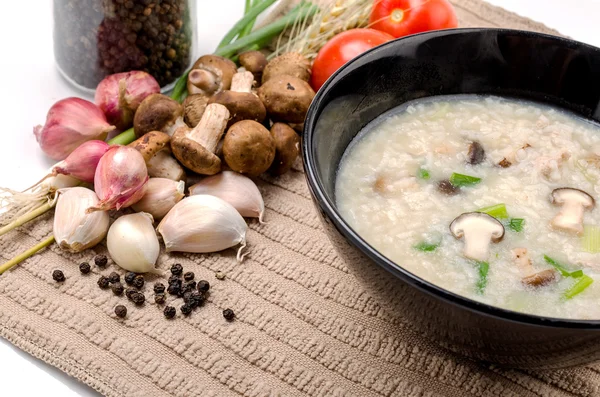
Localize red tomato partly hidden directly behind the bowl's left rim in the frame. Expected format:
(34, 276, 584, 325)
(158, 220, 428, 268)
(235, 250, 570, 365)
(310, 29, 394, 91)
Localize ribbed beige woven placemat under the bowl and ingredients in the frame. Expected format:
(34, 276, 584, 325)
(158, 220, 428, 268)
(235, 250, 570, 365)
(0, 0, 600, 397)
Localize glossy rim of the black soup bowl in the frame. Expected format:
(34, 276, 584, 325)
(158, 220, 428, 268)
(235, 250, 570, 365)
(302, 28, 600, 330)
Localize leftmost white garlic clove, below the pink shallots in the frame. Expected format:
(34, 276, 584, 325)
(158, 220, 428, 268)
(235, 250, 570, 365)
(53, 187, 109, 252)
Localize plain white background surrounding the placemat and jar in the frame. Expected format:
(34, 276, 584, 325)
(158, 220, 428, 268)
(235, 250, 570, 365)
(0, 0, 600, 397)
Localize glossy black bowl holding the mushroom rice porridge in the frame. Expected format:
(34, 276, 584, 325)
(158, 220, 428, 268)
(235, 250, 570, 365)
(302, 29, 600, 368)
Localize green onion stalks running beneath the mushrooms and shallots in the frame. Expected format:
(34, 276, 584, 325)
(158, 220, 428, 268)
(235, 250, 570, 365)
(0, 0, 318, 274)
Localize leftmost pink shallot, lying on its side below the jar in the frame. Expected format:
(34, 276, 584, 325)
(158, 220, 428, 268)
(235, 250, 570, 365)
(33, 97, 115, 160)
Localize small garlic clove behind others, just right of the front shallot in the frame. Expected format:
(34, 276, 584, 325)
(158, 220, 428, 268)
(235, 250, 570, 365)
(131, 178, 185, 219)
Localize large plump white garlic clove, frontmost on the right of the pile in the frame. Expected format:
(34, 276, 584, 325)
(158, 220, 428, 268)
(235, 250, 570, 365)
(157, 194, 248, 261)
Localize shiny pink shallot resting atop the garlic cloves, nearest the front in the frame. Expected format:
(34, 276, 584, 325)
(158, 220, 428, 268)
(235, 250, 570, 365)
(88, 146, 148, 211)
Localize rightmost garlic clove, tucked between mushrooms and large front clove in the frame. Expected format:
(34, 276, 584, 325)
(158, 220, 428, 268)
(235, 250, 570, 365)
(189, 171, 265, 223)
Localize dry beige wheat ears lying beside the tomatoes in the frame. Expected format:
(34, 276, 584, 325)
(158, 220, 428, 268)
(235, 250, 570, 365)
(273, 0, 373, 60)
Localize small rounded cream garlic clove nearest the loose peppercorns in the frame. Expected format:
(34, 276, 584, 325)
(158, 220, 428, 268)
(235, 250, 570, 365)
(106, 212, 162, 274)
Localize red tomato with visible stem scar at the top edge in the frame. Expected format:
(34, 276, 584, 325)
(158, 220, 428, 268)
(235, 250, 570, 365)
(369, 0, 458, 37)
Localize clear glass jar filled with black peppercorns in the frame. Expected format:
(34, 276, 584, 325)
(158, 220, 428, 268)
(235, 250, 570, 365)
(54, 0, 196, 90)
